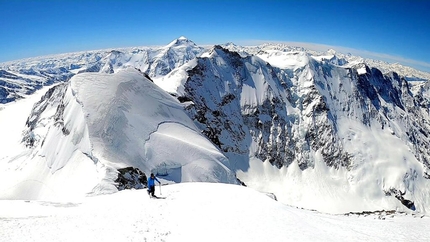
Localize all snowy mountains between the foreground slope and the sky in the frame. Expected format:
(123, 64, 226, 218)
(0, 37, 430, 213)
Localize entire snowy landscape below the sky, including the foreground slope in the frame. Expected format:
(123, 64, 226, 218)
(0, 37, 430, 242)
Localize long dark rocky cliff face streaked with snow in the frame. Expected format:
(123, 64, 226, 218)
(176, 46, 430, 176)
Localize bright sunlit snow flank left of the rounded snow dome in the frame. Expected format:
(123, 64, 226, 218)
(0, 84, 102, 200)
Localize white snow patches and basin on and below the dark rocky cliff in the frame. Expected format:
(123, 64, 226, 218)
(157, 48, 430, 213)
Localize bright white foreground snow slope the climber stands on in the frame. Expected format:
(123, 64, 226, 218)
(0, 183, 430, 242)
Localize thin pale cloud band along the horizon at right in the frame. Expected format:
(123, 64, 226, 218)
(237, 40, 430, 72)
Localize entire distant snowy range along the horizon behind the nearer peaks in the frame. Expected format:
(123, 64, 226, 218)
(0, 37, 430, 103)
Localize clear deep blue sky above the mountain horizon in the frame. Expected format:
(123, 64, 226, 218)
(0, 0, 430, 72)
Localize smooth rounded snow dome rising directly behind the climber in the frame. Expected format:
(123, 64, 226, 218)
(71, 69, 234, 182)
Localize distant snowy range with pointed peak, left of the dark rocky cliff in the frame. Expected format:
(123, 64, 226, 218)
(0, 37, 204, 103)
